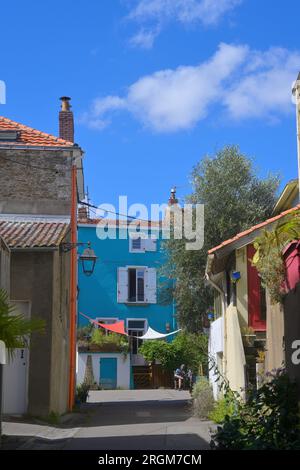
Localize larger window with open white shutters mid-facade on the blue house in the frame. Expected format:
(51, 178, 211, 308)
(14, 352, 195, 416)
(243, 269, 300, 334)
(117, 266, 156, 304)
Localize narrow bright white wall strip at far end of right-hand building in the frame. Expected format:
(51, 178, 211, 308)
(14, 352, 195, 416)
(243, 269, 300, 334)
(208, 317, 224, 399)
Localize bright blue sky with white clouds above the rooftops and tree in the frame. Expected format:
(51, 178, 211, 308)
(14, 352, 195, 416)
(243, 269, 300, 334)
(0, 0, 300, 209)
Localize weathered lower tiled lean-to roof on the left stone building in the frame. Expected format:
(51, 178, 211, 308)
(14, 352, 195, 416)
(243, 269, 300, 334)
(0, 220, 69, 248)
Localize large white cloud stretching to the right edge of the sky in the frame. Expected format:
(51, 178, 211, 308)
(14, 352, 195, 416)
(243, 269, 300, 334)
(82, 43, 300, 132)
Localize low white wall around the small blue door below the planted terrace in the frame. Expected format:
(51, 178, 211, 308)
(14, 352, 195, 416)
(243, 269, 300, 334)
(77, 353, 130, 390)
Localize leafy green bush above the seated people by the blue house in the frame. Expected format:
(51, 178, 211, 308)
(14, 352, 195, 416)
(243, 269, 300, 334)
(139, 333, 207, 373)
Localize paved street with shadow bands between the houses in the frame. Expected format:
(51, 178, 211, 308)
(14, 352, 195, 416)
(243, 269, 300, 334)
(3, 389, 214, 450)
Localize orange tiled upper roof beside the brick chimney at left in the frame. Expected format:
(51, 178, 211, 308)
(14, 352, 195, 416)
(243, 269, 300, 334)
(0, 116, 74, 147)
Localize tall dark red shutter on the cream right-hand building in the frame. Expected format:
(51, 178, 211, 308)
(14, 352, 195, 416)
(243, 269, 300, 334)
(247, 245, 266, 331)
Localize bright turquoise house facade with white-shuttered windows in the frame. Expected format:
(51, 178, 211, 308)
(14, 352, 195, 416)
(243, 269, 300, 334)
(78, 219, 177, 366)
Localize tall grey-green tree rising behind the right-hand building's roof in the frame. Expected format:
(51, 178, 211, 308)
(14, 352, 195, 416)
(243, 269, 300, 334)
(162, 146, 279, 332)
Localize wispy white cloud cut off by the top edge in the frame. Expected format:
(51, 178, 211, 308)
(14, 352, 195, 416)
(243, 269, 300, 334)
(128, 0, 243, 49)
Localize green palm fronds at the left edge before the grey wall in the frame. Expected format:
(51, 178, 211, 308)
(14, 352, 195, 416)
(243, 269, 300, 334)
(0, 289, 45, 355)
